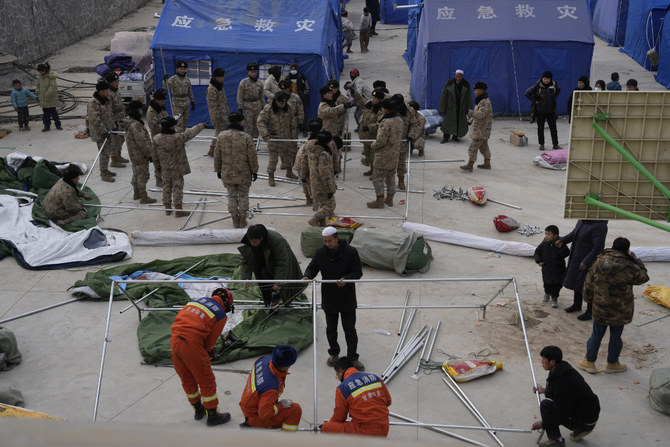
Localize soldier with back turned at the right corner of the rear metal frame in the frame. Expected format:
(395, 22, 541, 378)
(367, 98, 403, 208)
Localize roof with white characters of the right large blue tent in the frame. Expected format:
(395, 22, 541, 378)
(422, 0, 593, 43)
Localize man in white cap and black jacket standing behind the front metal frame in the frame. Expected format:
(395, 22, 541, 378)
(303, 227, 365, 371)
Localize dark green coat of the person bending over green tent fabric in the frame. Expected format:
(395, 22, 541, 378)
(237, 230, 305, 303)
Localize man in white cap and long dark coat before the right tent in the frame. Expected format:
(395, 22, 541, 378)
(438, 70, 473, 143)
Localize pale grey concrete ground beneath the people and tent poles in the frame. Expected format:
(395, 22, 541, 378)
(0, 0, 670, 446)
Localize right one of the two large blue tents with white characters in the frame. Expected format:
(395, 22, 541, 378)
(410, 0, 593, 115)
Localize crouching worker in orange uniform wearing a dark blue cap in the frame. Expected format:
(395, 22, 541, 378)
(240, 345, 302, 431)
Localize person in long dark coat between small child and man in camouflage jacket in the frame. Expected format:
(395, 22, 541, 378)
(556, 219, 607, 321)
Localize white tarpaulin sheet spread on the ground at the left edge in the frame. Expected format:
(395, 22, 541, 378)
(0, 195, 132, 270)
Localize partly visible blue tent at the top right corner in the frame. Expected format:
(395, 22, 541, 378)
(621, 0, 670, 70)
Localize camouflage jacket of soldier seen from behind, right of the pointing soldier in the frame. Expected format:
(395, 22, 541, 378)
(214, 128, 258, 186)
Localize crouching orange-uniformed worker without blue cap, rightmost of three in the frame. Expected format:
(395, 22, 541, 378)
(321, 357, 391, 437)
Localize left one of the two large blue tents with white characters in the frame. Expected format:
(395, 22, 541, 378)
(151, 0, 344, 126)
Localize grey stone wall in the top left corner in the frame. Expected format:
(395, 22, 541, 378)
(0, 0, 148, 63)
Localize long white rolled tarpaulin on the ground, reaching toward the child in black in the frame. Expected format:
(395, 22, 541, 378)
(402, 222, 535, 256)
